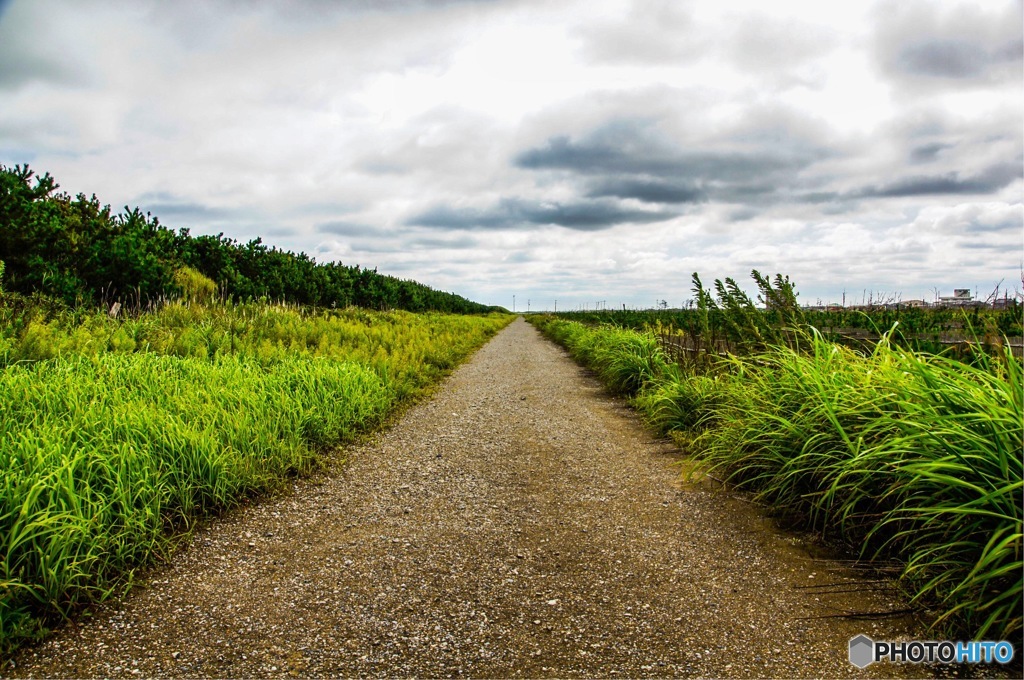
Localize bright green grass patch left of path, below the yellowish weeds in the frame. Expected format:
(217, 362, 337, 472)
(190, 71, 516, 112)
(0, 354, 393, 639)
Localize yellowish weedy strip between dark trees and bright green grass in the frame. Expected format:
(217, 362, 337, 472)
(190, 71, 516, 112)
(0, 300, 511, 396)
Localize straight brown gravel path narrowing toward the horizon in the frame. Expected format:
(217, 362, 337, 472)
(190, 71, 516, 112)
(3, 320, 927, 677)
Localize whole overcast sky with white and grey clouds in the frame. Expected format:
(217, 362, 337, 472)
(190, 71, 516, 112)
(0, 0, 1024, 309)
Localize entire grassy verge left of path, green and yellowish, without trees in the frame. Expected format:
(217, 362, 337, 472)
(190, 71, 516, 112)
(0, 305, 511, 652)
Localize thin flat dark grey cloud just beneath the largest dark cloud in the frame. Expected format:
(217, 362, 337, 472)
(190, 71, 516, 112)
(407, 199, 676, 231)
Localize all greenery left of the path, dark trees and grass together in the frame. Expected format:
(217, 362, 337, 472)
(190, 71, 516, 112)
(0, 166, 512, 656)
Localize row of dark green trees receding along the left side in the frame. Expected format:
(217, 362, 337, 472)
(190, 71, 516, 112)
(0, 165, 493, 313)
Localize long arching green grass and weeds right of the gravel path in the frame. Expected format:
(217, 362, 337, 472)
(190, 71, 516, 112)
(531, 272, 1024, 639)
